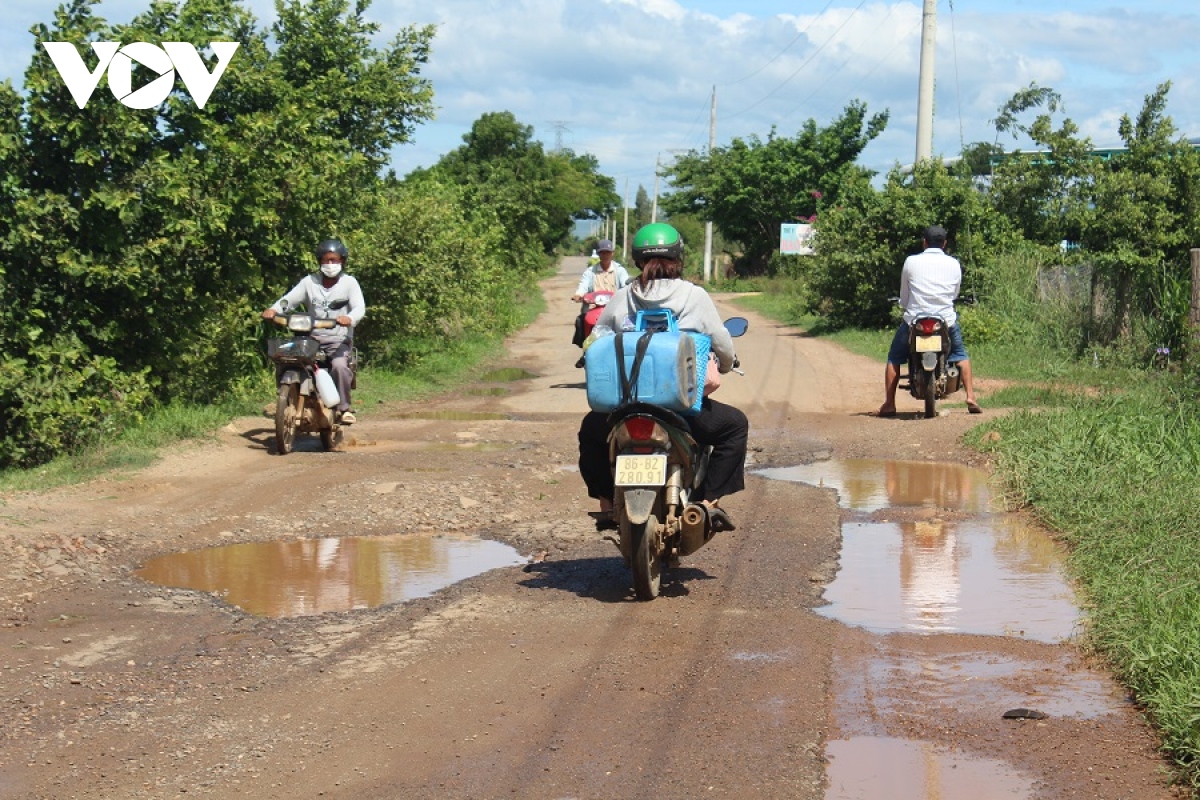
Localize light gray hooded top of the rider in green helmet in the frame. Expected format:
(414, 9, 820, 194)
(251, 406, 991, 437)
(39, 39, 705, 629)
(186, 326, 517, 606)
(596, 278, 733, 372)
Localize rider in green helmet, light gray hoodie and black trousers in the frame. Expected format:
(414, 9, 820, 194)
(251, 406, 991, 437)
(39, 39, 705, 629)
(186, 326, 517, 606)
(578, 222, 750, 530)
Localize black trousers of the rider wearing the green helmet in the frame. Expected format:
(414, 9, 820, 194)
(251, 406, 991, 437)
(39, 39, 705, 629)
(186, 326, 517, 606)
(580, 397, 750, 500)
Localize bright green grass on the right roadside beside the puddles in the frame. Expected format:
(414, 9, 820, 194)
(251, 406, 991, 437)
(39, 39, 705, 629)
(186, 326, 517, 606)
(968, 379, 1200, 789)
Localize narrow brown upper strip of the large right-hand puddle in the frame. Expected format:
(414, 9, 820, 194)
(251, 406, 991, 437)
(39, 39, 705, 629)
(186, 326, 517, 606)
(758, 458, 991, 513)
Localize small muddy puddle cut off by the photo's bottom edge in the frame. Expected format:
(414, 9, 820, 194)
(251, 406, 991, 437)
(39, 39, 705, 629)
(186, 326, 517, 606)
(826, 736, 1033, 800)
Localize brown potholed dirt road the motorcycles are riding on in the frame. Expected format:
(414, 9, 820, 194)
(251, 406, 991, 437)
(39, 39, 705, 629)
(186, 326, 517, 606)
(0, 259, 1174, 800)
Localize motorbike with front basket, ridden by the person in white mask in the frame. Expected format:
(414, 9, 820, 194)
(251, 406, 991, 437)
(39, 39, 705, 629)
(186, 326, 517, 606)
(266, 313, 358, 456)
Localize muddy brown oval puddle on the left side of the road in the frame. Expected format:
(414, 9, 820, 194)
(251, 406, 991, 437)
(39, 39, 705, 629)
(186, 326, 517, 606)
(134, 535, 527, 618)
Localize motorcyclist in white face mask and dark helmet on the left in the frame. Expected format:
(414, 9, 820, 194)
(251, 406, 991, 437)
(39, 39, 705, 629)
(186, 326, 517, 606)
(263, 239, 367, 425)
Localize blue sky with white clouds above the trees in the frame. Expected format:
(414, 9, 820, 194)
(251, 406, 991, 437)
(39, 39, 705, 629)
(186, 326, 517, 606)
(9, 0, 1200, 198)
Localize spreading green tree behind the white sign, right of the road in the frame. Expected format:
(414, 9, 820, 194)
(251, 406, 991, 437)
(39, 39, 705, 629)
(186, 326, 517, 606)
(664, 102, 888, 271)
